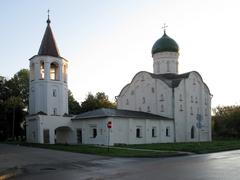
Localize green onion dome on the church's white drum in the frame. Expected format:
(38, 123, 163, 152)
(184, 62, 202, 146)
(152, 31, 179, 55)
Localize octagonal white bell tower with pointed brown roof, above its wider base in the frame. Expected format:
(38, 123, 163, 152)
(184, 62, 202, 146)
(29, 14, 68, 116)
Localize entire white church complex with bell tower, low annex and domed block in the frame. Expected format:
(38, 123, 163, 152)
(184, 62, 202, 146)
(26, 18, 212, 145)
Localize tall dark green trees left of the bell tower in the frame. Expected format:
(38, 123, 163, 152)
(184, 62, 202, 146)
(0, 69, 29, 140)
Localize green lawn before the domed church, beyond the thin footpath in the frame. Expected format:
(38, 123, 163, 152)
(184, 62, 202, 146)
(123, 140, 240, 154)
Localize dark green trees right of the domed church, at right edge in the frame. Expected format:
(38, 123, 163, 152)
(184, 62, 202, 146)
(213, 106, 240, 138)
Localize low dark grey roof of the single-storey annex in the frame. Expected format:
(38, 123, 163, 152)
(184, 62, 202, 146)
(72, 108, 172, 120)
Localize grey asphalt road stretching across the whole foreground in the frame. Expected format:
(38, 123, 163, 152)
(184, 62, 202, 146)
(0, 145, 240, 180)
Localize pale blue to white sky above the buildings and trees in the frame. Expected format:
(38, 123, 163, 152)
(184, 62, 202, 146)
(0, 0, 240, 108)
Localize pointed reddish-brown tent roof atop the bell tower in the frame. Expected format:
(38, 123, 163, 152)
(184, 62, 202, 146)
(38, 18, 60, 57)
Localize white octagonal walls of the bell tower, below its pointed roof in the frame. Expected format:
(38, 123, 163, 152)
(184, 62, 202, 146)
(29, 56, 68, 115)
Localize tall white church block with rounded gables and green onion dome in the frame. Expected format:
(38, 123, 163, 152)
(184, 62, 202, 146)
(117, 30, 212, 142)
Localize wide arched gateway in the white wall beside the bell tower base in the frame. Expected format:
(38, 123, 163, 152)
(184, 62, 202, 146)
(55, 126, 73, 144)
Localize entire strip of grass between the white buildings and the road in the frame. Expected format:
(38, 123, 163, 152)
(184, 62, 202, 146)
(4, 140, 240, 157)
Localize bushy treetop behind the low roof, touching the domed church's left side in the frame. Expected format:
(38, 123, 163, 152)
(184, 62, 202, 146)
(81, 92, 116, 112)
